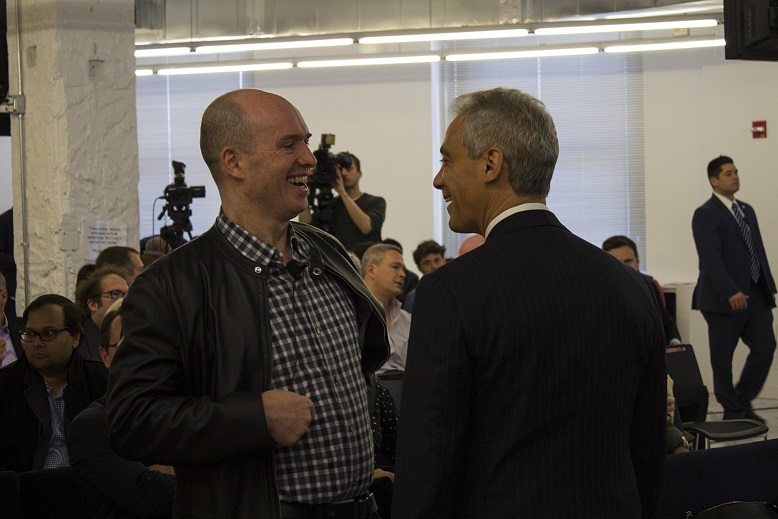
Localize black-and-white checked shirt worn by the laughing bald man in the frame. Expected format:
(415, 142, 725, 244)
(216, 214, 373, 504)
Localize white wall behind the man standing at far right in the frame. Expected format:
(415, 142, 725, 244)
(644, 49, 778, 398)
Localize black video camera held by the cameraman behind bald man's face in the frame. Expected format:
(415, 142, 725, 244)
(308, 133, 354, 233)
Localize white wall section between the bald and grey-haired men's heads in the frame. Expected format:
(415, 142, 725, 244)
(252, 65, 438, 270)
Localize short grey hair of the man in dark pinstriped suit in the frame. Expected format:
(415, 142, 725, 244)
(451, 87, 559, 197)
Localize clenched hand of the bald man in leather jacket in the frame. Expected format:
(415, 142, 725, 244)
(262, 389, 314, 447)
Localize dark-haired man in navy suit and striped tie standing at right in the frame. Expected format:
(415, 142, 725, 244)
(692, 155, 775, 422)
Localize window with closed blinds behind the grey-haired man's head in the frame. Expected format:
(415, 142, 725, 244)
(433, 54, 646, 257)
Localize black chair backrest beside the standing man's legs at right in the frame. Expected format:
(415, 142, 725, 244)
(665, 344, 710, 422)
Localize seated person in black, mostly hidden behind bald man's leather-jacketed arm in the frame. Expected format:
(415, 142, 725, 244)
(67, 299, 176, 519)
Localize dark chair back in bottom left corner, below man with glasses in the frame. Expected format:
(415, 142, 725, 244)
(19, 467, 88, 519)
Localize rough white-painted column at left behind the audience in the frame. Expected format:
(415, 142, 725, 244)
(7, 0, 138, 308)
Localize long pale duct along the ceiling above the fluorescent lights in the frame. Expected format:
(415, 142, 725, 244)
(135, 0, 708, 42)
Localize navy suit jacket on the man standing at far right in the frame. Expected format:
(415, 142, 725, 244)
(692, 195, 775, 313)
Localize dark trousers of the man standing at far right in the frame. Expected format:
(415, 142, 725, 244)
(702, 285, 775, 419)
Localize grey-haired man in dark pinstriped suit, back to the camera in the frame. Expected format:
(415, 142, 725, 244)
(392, 88, 666, 519)
